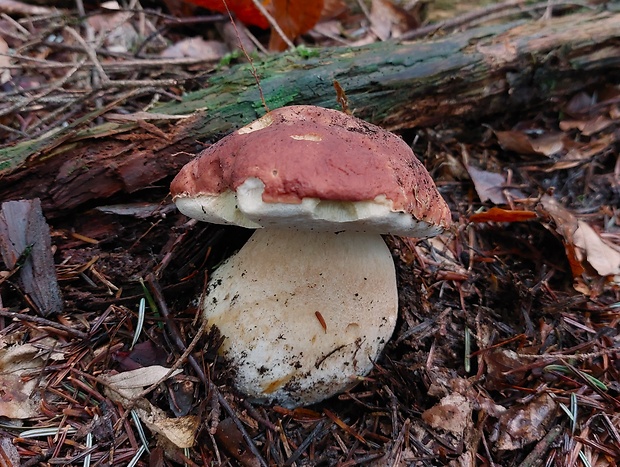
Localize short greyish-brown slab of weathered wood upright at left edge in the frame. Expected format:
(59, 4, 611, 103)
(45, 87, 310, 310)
(0, 199, 63, 316)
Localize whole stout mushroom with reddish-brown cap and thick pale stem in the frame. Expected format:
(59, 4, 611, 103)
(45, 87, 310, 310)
(171, 106, 450, 408)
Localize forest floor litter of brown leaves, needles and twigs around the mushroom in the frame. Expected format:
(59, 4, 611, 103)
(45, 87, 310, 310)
(0, 0, 620, 466)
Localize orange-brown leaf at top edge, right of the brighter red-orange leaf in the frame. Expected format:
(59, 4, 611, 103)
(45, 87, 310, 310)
(269, 0, 323, 50)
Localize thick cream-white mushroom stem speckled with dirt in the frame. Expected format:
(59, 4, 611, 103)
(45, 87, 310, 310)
(203, 229, 398, 407)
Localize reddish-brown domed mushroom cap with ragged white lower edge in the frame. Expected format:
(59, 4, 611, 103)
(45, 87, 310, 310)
(171, 106, 450, 236)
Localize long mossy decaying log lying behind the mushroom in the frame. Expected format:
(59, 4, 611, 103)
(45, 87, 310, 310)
(0, 12, 620, 215)
